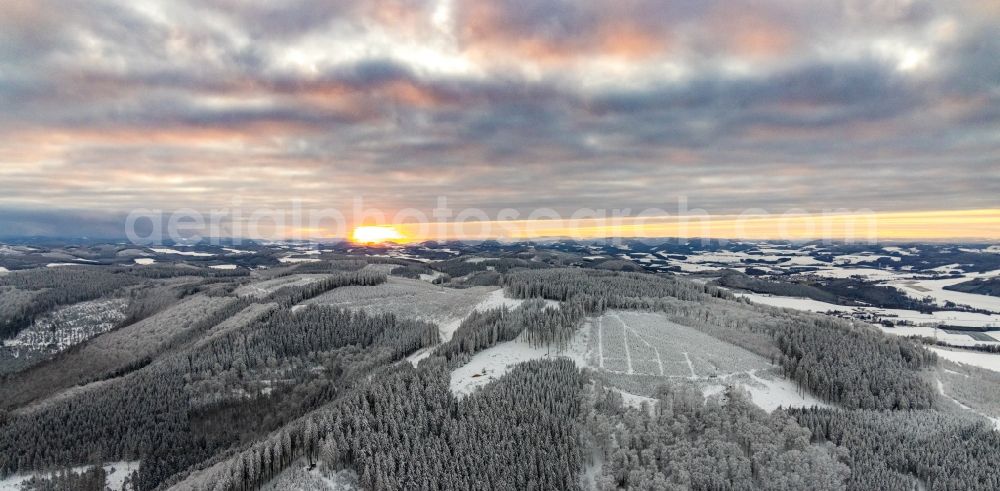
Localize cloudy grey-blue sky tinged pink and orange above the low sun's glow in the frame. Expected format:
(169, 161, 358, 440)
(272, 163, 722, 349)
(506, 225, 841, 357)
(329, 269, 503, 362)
(0, 0, 1000, 240)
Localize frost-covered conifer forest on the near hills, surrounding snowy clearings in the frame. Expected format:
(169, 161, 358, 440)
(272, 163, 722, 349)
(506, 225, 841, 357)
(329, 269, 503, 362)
(0, 258, 1000, 490)
